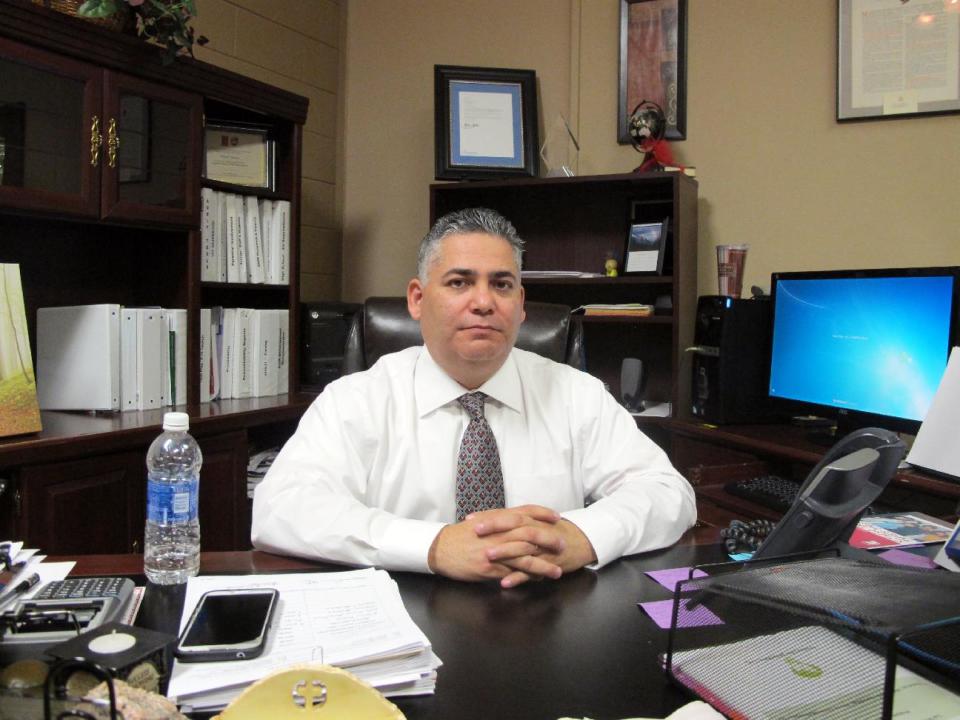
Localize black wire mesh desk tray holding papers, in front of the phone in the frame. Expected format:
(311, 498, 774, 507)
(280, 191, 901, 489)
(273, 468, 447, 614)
(662, 557, 960, 720)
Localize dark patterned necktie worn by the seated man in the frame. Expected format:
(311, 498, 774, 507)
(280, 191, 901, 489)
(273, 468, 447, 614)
(457, 392, 504, 522)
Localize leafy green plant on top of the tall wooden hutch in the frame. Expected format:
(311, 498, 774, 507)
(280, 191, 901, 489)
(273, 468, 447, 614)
(77, 0, 207, 65)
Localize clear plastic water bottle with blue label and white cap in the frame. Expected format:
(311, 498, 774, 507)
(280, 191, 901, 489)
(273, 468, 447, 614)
(143, 412, 203, 585)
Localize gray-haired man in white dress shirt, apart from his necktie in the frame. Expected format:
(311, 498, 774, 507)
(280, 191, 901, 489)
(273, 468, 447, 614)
(251, 209, 696, 587)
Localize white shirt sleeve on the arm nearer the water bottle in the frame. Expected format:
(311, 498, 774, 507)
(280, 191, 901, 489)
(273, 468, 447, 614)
(251, 378, 444, 572)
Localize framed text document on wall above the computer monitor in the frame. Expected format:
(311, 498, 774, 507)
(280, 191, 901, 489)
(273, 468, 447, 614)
(837, 0, 960, 121)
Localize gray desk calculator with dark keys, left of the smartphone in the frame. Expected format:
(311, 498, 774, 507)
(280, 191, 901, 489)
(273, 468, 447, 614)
(0, 577, 135, 665)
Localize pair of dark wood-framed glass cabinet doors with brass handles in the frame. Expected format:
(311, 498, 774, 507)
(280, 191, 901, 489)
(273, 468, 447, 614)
(0, 38, 202, 226)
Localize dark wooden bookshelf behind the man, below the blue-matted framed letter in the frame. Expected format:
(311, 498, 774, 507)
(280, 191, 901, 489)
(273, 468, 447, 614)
(430, 172, 697, 411)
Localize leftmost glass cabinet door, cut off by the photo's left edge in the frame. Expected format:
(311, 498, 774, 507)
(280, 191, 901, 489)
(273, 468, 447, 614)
(0, 39, 102, 216)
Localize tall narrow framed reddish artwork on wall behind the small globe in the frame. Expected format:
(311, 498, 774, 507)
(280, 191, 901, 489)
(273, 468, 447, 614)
(617, 0, 687, 145)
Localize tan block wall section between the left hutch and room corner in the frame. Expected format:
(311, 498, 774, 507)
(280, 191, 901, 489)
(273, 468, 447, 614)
(195, 0, 342, 300)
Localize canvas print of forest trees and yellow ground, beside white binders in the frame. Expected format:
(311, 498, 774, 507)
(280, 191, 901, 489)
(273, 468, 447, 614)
(0, 263, 40, 437)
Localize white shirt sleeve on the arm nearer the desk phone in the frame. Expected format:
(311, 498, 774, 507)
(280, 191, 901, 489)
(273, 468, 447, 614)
(562, 376, 697, 568)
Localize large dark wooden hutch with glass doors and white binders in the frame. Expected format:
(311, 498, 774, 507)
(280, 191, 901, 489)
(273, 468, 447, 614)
(0, 0, 312, 554)
